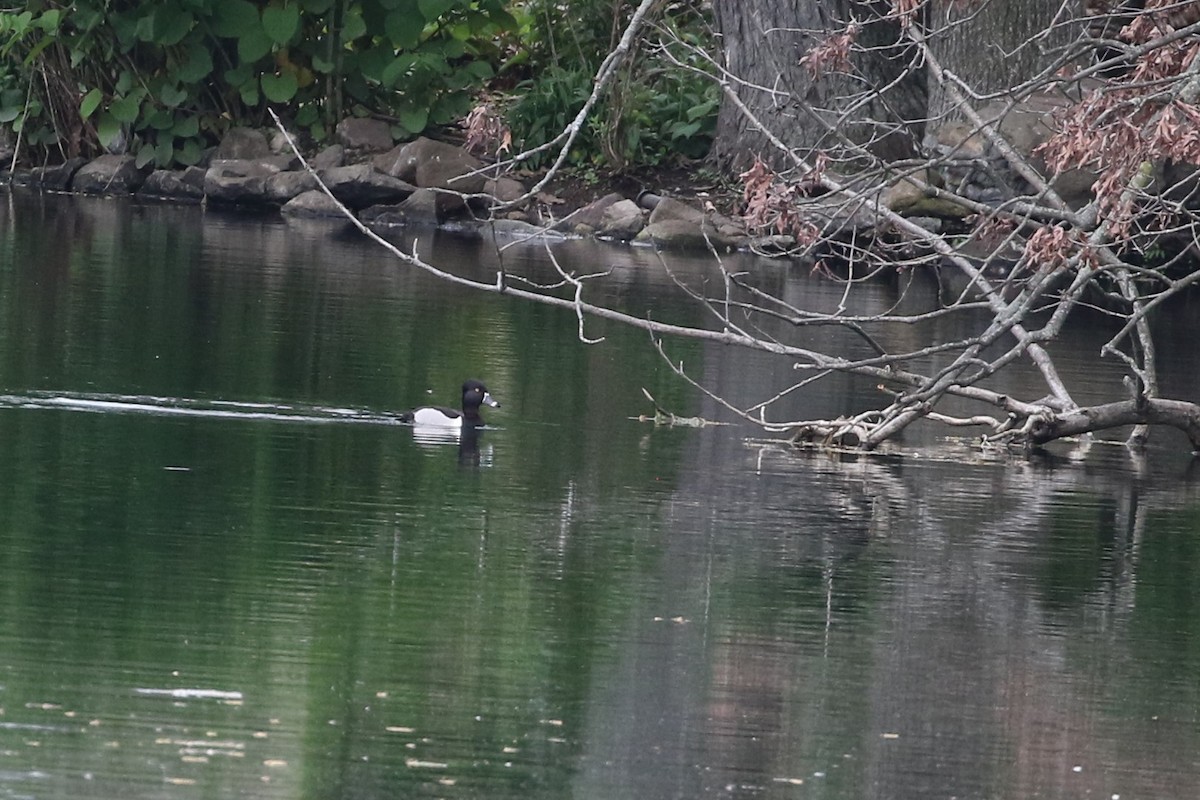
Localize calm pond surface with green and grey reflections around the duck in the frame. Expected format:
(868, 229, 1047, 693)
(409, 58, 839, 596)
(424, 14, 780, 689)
(0, 189, 1200, 800)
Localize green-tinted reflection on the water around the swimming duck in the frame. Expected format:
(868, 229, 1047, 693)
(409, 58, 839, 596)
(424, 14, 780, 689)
(0, 190, 689, 798)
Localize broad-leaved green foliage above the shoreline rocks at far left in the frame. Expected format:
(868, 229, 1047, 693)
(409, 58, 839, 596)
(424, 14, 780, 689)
(0, 0, 517, 166)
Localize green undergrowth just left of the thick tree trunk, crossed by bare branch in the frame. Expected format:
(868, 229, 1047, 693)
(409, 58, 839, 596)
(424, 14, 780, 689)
(508, 0, 720, 170)
